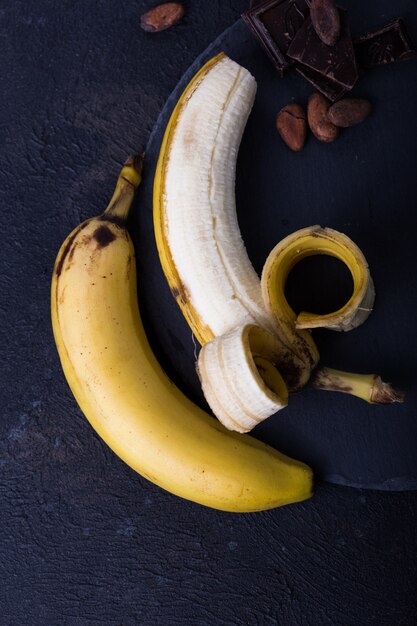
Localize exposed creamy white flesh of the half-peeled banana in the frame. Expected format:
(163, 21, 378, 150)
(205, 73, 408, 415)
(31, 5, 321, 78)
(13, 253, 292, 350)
(162, 55, 272, 336)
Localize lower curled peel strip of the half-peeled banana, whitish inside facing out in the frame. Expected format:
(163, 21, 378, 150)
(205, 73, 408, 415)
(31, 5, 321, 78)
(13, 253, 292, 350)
(197, 325, 288, 433)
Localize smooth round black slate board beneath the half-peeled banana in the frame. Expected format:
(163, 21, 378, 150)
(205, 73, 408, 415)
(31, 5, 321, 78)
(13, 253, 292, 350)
(132, 8, 417, 490)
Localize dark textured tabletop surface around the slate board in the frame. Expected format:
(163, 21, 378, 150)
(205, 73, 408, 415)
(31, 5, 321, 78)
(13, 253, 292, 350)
(0, 0, 417, 626)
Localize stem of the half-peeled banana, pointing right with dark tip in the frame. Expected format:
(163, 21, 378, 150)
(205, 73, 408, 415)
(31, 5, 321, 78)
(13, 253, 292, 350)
(310, 367, 404, 404)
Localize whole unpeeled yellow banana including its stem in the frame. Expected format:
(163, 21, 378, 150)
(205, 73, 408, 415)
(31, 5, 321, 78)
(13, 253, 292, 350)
(51, 160, 312, 512)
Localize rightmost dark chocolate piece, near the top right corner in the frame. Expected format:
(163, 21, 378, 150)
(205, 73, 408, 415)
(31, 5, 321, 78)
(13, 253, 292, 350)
(354, 18, 416, 68)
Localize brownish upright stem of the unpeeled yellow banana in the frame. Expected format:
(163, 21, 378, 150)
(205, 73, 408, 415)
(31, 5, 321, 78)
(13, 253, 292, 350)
(102, 154, 144, 225)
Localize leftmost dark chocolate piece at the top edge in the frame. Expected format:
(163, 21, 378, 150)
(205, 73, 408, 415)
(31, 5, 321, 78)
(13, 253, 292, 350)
(242, 0, 309, 75)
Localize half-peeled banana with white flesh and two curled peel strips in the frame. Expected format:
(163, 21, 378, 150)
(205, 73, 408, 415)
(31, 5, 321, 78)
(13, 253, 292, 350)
(154, 53, 404, 431)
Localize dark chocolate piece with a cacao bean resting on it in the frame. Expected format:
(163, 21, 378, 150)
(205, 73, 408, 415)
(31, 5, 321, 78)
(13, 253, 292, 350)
(287, 10, 358, 89)
